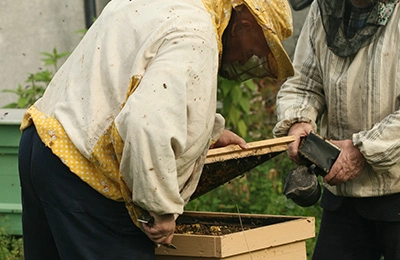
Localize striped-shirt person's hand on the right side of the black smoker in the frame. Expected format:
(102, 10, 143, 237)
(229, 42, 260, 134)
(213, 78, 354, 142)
(324, 140, 366, 185)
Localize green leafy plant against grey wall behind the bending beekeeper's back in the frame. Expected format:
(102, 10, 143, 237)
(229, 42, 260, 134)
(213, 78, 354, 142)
(3, 48, 70, 108)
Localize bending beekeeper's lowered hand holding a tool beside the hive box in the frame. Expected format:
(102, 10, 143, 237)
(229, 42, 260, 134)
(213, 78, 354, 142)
(142, 212, 176, 245)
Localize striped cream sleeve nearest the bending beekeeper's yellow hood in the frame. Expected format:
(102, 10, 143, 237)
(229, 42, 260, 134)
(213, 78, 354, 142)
(273, 3, 325, 137)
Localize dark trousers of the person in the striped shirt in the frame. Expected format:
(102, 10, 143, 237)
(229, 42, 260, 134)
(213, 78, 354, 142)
(312, 190, 400, 260)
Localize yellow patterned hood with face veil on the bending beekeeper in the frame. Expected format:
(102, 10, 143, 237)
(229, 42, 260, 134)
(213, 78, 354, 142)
(202, 0, 293, 80)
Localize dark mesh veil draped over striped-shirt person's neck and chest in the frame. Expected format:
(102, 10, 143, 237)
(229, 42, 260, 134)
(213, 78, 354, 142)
(318, 0, 399, 57)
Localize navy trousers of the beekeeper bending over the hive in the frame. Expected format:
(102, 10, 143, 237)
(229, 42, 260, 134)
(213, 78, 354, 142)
(19, 126, 155, 260)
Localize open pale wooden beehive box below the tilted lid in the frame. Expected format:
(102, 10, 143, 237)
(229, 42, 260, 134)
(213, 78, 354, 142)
(156, 212, 315, 260)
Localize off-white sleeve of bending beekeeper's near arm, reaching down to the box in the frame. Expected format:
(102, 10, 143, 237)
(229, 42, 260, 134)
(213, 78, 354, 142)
(112, 31, 218, 214)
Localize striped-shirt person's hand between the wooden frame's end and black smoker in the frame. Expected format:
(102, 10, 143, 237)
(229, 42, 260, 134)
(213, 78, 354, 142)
(287, 122, 313, 165)
